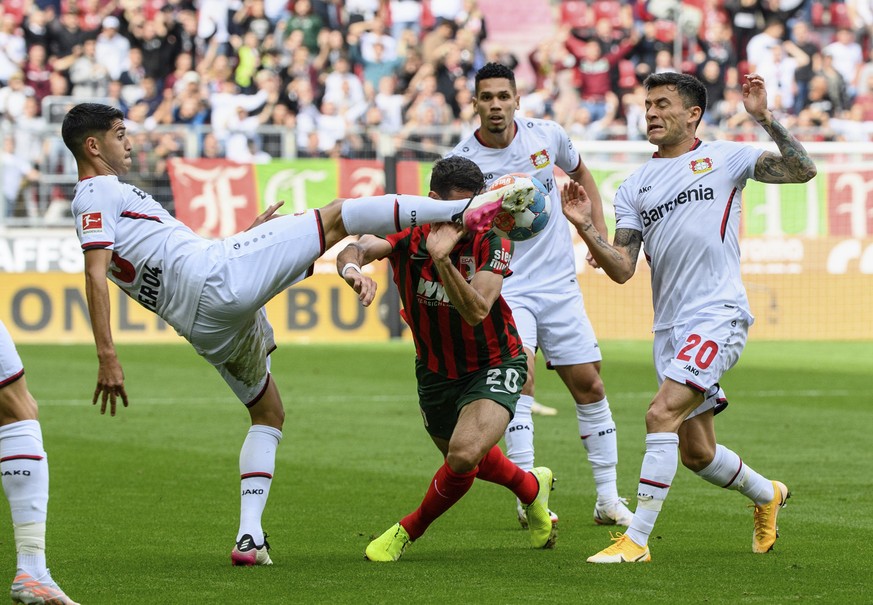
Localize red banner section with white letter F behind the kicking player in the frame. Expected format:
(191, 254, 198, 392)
(169, 158, 258, 238)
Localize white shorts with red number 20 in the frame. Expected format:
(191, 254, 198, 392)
(653, 309, 749, 420)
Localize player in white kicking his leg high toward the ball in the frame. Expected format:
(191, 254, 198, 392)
(61, 103, 534, 565)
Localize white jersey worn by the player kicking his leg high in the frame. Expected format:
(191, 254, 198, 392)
(72, 176, 215, 337)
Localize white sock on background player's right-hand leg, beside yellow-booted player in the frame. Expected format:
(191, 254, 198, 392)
(576, 397, 618, 504)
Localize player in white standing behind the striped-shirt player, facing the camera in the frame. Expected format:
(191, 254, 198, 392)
(450, 63, 633, 526)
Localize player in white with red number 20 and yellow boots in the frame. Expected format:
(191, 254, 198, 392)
(561, 73, 816, 563)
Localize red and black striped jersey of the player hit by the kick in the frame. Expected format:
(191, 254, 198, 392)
(386, 225, 522, 379)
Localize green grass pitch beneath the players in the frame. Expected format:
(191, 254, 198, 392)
(8, 337, 873, 605)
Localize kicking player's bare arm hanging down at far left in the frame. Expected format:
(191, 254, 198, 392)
(85, 250, 127, 416)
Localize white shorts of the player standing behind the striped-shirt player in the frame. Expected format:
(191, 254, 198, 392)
(504, 287, 603, 366)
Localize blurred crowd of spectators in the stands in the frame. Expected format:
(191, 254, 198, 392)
(0, 0, 873, 217)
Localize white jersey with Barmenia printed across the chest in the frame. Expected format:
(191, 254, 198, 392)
(615, 141, 763, 330)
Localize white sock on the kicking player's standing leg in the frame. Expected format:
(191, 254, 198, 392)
(236, 424, 282, 546)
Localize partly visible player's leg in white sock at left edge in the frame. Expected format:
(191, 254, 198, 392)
(0, 322, 77, 605)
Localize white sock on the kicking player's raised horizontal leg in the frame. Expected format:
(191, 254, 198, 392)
(343, 194, 470, 235)
